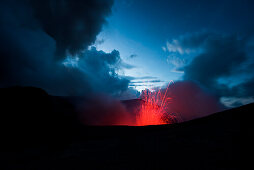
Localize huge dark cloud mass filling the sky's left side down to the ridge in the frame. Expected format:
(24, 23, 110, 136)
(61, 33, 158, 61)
(0, 0, 129, 95)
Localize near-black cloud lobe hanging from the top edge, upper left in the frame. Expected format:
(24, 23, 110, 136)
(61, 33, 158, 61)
(29, 0, 113, 56)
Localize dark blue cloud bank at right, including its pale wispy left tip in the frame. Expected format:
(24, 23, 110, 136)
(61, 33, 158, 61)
(167, 32, 254, 105)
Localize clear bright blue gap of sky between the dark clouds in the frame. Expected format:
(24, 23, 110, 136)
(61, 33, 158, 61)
(97, 0, 254, 89)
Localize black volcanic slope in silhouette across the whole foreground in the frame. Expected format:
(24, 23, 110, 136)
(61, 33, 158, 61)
(0, 88, 250, 170)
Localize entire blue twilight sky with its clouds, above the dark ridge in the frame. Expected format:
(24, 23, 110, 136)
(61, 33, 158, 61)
(0, 0, 254, 106)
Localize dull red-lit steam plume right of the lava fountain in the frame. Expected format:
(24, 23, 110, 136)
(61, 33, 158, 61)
(154, 81, 223, 122)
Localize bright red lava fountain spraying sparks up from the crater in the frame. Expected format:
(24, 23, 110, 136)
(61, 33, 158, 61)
(136, 83, 175, 126)
